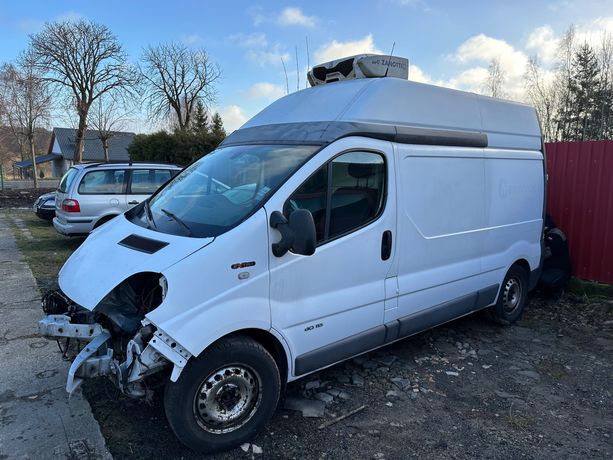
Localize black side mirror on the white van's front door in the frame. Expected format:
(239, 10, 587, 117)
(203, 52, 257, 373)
(270, 209, 316, 257)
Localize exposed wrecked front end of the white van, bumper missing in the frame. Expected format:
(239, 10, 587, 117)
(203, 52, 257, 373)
(38, 273, 191, 398)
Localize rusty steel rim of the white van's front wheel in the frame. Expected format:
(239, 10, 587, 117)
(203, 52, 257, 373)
(194, 364, 262, 434)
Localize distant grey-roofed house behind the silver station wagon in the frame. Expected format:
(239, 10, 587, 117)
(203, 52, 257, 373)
(14, 128, 134, 177)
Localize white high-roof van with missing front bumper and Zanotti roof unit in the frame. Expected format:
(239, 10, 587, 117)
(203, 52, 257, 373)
(39, 55, 546, 452)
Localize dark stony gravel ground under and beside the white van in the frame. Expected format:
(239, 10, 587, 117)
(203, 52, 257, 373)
(85, 294, 613, 459)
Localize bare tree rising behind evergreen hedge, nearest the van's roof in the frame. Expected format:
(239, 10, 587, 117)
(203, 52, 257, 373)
(140, 43, 221, 130)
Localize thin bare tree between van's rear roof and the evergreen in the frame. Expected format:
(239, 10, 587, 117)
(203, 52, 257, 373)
(524, 56, 559, 141)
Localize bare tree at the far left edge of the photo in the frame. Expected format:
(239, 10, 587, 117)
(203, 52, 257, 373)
(0, 52, 51, 188)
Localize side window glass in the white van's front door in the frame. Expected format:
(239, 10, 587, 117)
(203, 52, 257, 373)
(283, 152, 386, 244)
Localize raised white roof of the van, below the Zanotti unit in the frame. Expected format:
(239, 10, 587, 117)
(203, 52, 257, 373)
(223, 78, 541, 150)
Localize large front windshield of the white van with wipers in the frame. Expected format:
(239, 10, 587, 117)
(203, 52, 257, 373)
(126, 145, 319, 238)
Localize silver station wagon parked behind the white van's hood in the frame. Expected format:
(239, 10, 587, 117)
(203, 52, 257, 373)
(53, 163, 181, 236)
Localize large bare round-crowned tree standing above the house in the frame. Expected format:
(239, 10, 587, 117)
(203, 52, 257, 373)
(31, 20, 137, 163)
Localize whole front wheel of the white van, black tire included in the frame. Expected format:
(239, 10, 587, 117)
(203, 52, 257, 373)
(164, 335, 281, 454)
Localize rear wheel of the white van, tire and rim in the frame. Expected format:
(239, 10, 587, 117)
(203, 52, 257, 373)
(490, 265, 528, 326)
